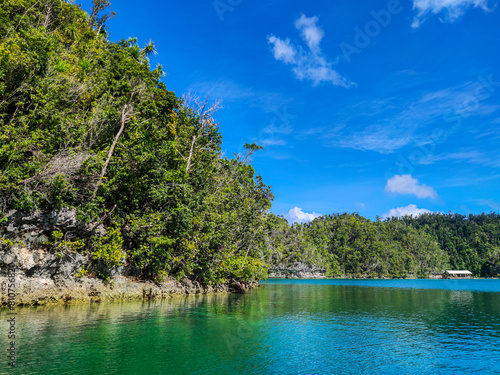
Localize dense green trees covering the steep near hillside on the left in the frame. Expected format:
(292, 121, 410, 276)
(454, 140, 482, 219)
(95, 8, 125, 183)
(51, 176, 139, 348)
(0, 0, 272, 282)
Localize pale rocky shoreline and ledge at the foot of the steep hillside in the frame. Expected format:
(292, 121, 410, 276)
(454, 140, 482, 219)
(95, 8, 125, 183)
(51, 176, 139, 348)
(0, 209, 259, 306)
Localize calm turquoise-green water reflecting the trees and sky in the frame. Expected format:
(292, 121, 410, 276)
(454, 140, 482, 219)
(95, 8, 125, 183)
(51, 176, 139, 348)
(0, 280, 500, 375)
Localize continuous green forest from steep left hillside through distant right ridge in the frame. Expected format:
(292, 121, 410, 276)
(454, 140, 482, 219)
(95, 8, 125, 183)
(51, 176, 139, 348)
(0, 0, 500, 283)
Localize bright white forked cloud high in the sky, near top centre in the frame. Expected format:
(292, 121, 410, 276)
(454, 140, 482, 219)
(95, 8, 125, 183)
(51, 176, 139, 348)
(267, 15, 354, 87)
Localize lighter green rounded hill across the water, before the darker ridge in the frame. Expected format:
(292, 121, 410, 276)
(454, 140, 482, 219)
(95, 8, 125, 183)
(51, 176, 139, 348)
(290, 214, 448, 278)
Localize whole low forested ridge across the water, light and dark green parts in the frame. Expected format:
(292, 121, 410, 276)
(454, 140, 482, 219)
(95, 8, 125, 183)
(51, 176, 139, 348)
(295, 213, 500, 277)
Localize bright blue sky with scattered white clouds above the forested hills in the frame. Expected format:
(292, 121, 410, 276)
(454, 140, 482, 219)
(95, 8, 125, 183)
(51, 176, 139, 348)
(79, 0, 500, 221)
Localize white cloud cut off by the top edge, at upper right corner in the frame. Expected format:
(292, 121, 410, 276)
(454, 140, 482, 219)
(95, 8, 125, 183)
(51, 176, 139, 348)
(412, 0, 489, 28)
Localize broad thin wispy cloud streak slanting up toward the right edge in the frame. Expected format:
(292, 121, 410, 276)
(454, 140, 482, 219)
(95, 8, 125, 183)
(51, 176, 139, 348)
(304, 81, 500, 154)
